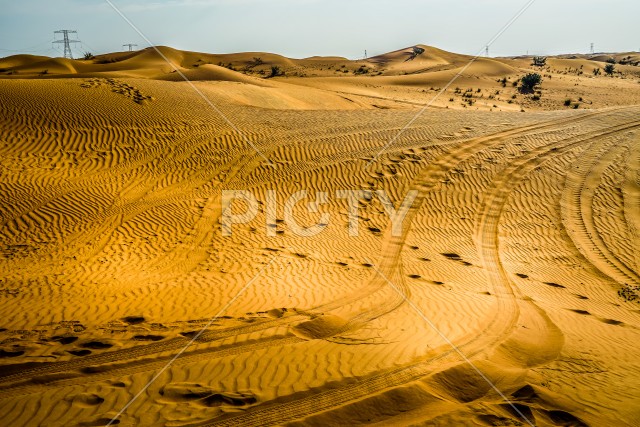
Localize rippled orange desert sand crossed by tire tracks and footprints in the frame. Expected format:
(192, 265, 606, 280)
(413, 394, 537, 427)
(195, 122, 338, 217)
(0, 46, 640, 426)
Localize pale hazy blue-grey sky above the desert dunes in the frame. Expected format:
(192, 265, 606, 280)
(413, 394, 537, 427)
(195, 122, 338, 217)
(0, 0, 640, 58)
